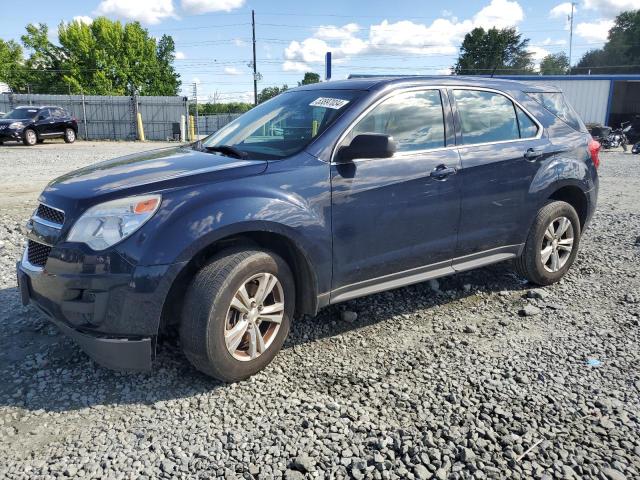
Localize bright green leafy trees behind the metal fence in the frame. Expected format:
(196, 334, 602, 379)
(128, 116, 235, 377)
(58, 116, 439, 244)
(1, 17, 180, 95)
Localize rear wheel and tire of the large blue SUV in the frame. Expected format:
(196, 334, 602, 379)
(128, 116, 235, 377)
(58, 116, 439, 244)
(514, 201, 581, 286)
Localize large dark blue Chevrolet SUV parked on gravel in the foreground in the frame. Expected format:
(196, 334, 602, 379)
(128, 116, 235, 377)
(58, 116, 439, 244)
(18, 77, 599, 381)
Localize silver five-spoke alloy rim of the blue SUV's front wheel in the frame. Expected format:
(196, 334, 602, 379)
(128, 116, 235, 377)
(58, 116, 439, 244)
(224, 273, 285, 361)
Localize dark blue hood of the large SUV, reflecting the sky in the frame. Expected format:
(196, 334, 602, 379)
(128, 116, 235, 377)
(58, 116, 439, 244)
(40, 146, 267, 205)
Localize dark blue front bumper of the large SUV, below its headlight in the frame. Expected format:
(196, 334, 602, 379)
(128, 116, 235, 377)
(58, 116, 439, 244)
(16, 255, 184, 371)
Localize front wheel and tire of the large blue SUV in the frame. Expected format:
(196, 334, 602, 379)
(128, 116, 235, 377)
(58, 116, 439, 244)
(180, 248, 295, 382)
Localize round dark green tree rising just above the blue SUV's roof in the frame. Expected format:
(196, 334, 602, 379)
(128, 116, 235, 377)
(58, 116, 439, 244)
(454, 27, 533, 75)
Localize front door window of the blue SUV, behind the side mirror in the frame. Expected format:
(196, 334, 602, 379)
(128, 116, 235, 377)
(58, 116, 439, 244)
(344, 90, 445, 152)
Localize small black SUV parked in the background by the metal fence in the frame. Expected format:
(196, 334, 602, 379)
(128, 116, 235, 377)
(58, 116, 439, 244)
(0, 106, 78, 146)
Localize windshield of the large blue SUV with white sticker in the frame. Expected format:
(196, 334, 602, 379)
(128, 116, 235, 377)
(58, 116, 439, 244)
(202, 90, 362, 159)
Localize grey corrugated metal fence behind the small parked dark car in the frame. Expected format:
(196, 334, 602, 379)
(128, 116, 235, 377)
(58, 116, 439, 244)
(0, 93, 188, 140)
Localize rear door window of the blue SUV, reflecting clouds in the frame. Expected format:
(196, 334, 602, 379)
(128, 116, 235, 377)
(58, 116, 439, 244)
(453, 90, 520, 145)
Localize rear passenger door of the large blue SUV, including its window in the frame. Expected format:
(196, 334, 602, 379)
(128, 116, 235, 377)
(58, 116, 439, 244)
(450, 87, 551, 264)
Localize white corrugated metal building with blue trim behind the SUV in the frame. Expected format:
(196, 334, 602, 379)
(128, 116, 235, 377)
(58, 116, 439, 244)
(496, 75, 640, 126)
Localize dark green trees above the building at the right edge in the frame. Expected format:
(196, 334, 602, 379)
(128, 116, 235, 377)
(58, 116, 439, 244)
(572, 10, 640, 73)
